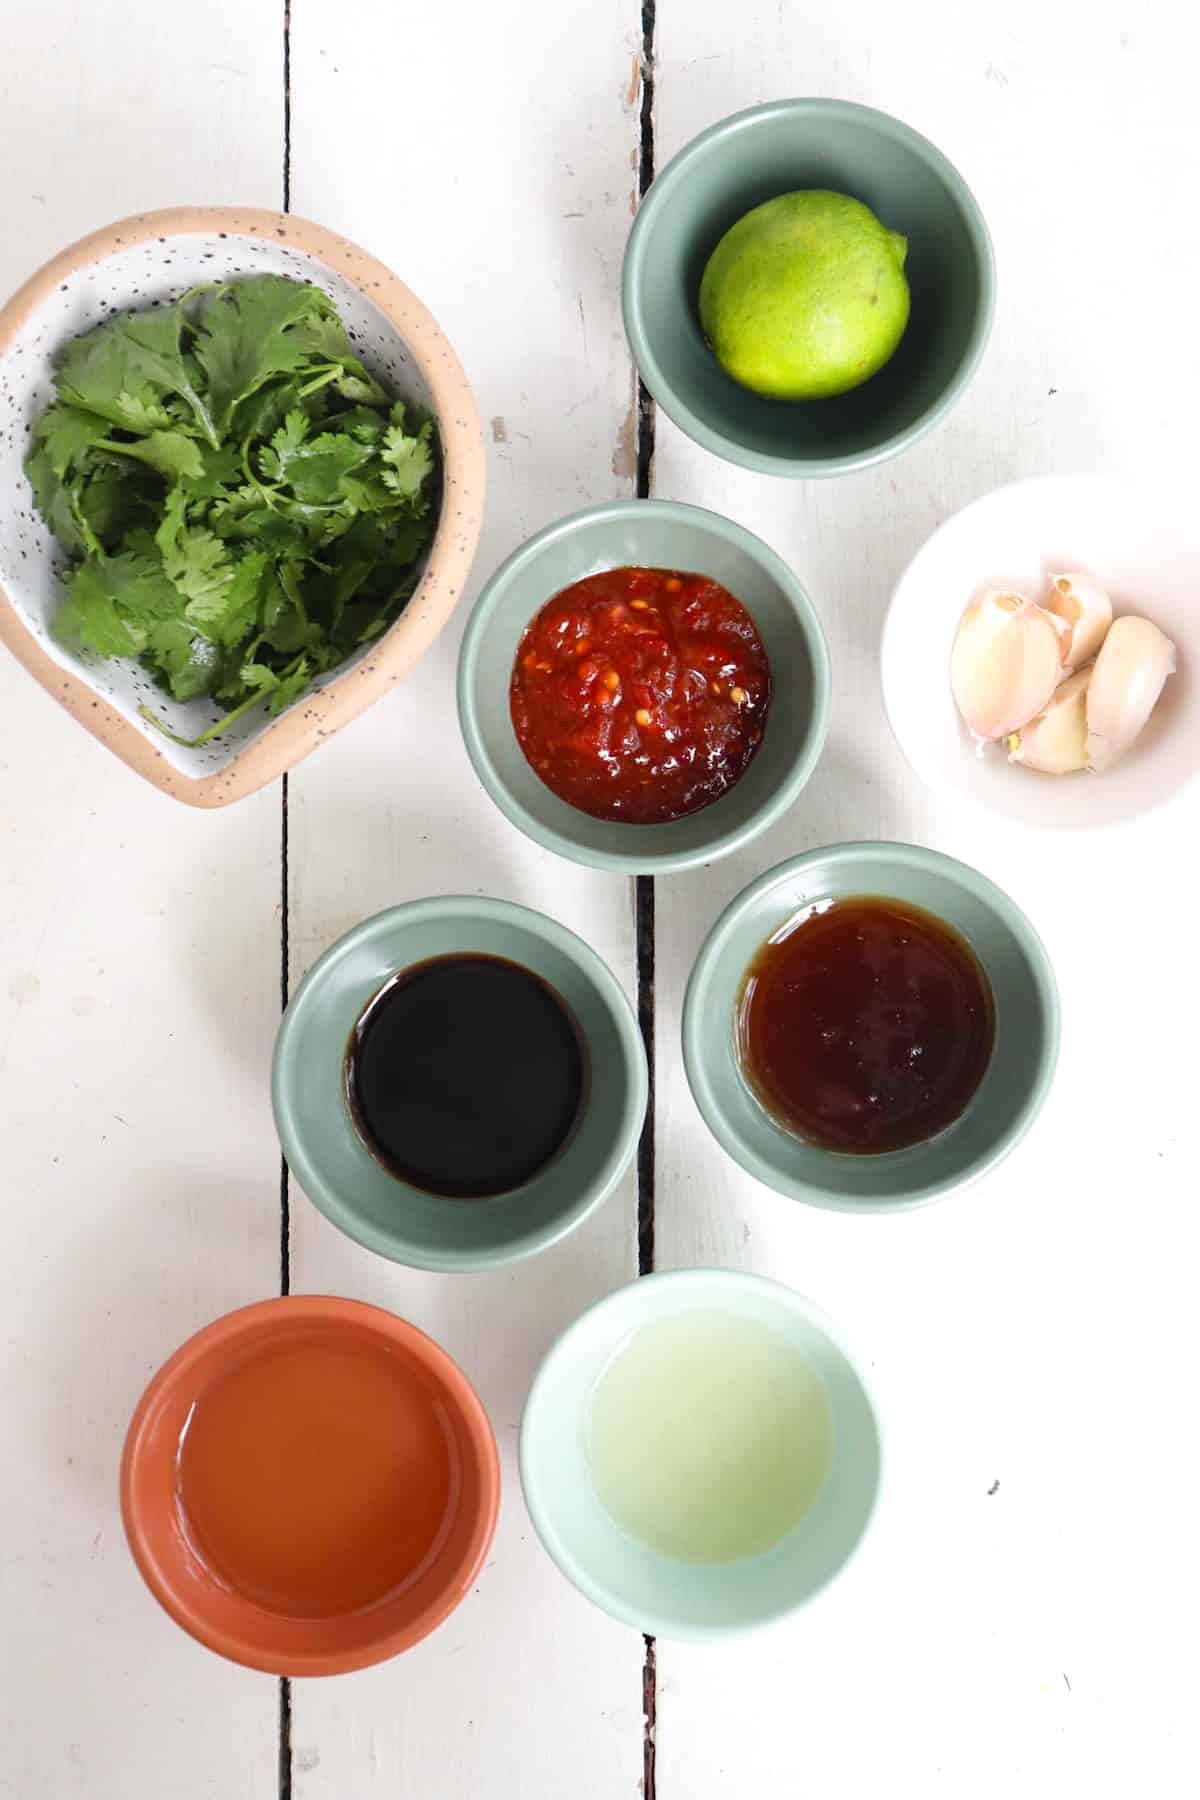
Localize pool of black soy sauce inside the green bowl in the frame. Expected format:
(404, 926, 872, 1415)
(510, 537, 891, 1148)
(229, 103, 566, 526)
(345, 956, 587, 1201)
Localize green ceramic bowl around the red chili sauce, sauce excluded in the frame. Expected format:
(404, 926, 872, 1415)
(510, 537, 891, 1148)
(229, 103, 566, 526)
(459, 500, 829, 875)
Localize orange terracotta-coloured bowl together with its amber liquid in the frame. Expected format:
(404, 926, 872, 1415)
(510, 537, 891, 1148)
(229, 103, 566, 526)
(121, 1294, 500, 1676)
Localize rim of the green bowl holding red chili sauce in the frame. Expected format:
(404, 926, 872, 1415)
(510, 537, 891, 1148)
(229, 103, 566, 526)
(459, 499, 833, 875)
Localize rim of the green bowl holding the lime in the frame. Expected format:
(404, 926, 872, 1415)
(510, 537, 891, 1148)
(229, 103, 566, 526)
(621, 97, 997, 481)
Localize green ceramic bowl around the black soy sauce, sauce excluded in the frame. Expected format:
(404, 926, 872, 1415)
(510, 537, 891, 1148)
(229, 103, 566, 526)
(272, 895, 648, 1269)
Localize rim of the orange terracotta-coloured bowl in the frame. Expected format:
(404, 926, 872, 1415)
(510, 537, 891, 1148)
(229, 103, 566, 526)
(121, 1294, 500, 1676)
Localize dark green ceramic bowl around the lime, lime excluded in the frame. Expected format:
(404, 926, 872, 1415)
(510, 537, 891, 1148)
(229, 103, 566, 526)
(622, 99, 995, 477)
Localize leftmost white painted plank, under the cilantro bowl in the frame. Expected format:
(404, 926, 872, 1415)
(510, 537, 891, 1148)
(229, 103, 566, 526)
(0, 0, 282, 1800)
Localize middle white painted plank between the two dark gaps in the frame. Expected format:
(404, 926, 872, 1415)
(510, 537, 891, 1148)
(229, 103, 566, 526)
(290, 0, 642, 1800)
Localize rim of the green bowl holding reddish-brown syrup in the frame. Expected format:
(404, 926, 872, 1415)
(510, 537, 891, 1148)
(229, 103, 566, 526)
(682, 839, 1061, 1213)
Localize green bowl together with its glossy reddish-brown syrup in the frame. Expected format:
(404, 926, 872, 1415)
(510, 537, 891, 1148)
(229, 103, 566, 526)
(684, 844, 1060, 1211)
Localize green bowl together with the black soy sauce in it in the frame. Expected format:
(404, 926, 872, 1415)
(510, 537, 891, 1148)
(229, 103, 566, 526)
(272, 895, 648, 1271)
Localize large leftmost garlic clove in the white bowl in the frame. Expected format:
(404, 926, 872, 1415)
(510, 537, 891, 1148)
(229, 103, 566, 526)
(950, 589, 1063, 738)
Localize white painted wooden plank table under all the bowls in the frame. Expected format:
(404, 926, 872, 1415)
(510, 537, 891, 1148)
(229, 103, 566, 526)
(0, 0, 1200, 1800)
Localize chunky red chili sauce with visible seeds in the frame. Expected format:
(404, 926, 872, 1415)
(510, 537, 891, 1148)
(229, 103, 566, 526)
(511, 569, 770, 824)
